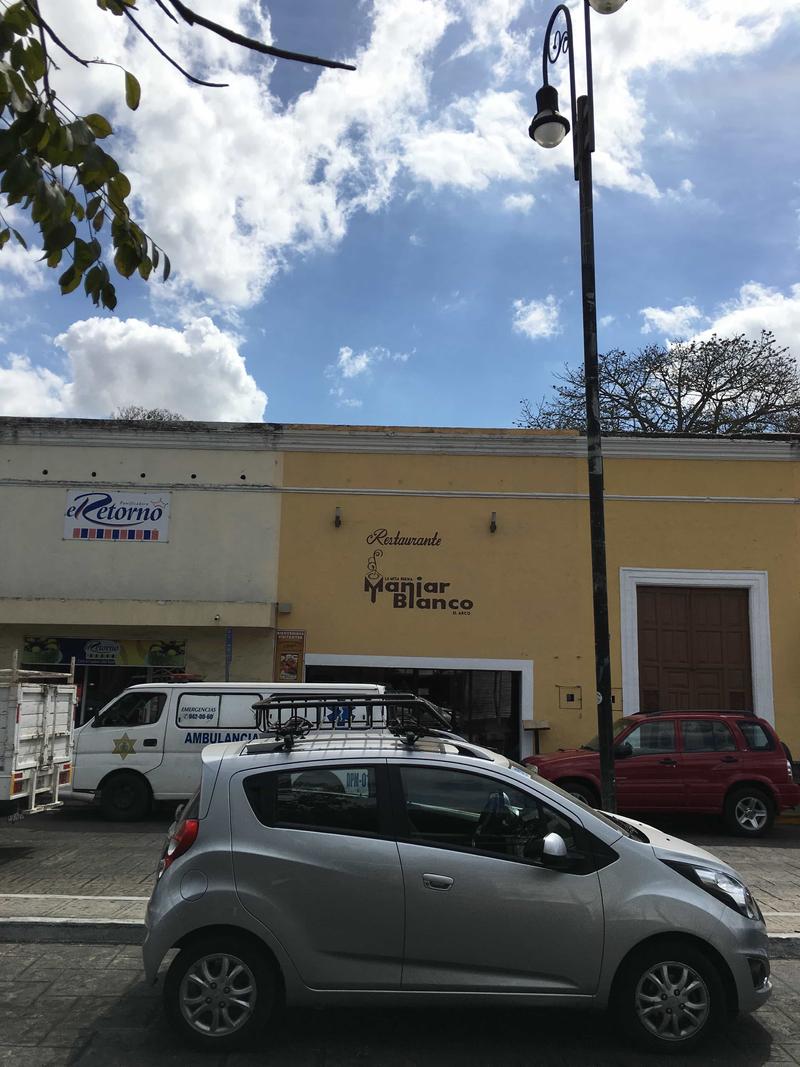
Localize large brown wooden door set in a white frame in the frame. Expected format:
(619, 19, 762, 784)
(638, 586, 753, 712)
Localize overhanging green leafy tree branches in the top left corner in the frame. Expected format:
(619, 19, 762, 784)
(0, 0, 354, 309)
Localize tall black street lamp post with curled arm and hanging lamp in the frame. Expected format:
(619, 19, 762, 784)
(529, 0, 625, 811)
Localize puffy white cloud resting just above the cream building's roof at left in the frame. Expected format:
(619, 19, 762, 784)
(0, 318, 267, 421)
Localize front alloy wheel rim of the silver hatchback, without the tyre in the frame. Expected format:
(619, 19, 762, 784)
(636, 960, 710, 1041)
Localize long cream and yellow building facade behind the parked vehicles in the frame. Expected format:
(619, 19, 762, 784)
(0, 418, 800, 757)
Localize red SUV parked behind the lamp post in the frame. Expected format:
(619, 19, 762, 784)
(524, 712, 800, 838)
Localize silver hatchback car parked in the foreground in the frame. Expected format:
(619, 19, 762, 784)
(143, 730, 771, 1052)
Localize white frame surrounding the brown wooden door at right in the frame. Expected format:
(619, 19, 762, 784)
(620, 567, 774, 722)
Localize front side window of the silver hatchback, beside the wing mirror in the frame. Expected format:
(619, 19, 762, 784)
(400, 767, 582, 863)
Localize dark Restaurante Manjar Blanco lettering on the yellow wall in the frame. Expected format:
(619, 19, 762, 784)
(364, 527, 475, 615)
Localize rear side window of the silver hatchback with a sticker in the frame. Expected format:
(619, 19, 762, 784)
(244, 766, 380, 835)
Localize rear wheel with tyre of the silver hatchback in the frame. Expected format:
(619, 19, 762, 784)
(164, 934, 277, 1052)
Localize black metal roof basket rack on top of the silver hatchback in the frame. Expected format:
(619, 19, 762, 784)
(247, 692, 464, 753)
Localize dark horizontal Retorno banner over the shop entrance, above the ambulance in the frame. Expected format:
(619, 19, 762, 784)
(22, 635, 186, 668)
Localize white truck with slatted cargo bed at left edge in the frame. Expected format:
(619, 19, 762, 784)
(0, 652, 77, 816)
